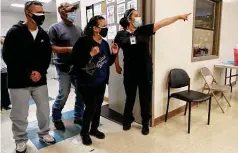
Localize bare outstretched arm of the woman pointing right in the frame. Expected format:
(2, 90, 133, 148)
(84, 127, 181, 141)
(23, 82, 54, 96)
(154, 13, 191, 32)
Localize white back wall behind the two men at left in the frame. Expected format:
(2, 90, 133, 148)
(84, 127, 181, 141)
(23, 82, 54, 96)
(1, 12, 57, 36)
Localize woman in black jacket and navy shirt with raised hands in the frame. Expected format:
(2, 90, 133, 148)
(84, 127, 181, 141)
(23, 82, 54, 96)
(71, 16, 118, 145)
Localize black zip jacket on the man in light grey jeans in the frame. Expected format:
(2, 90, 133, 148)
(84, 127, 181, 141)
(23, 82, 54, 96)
(2, 21, 52, 88)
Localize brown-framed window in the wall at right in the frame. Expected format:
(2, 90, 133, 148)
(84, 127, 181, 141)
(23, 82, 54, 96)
(192, 0, 222, 61)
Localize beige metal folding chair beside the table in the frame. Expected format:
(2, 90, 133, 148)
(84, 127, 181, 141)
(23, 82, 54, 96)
(200, 67, 231, 113)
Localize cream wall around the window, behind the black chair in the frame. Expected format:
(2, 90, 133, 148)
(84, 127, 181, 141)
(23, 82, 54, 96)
(154, 0, 238, 118)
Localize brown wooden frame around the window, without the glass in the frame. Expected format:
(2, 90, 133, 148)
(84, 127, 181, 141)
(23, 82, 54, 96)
(191, 0, 223, 62)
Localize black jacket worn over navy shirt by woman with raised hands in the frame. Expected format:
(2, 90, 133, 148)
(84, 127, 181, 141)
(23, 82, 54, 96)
(70, 36, 117, 85)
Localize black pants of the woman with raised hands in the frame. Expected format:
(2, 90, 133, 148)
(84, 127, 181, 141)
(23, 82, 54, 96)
(79, 84, 106, 135)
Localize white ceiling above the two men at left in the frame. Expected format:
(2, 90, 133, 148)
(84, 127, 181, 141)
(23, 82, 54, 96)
(1, 0, 56, 14)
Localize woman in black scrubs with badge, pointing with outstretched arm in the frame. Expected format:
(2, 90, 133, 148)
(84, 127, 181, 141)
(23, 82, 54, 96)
(114, 9, 190, 135)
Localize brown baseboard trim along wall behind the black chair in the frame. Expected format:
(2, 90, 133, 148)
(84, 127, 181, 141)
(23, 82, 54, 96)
(154, 103, 198, 126)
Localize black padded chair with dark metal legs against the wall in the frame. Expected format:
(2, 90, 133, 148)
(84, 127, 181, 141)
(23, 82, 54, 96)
(165, 69, 211, 133)
